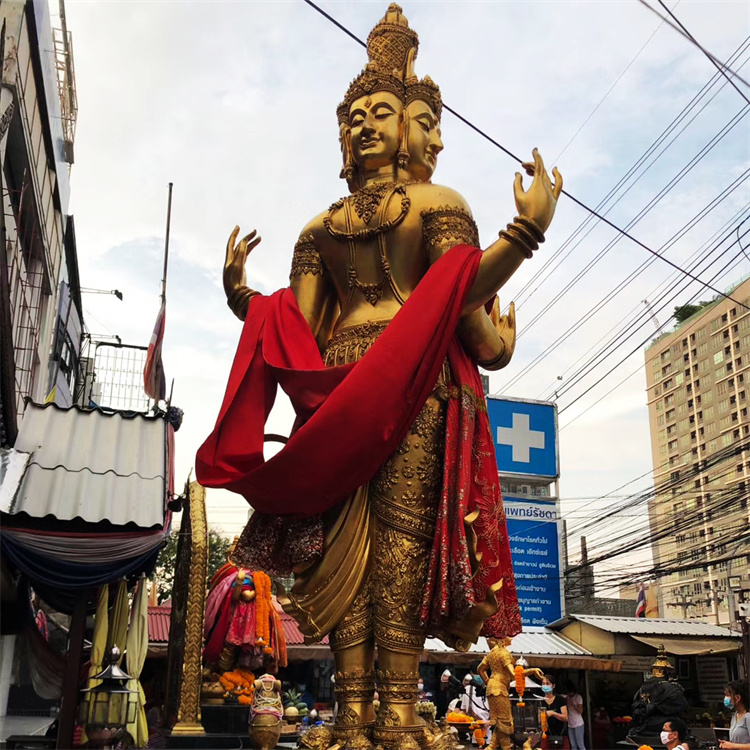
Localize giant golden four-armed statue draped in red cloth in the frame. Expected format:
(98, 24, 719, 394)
(196, 5, 562, 748)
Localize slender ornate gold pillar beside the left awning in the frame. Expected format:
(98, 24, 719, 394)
(172, 482, 208, 736)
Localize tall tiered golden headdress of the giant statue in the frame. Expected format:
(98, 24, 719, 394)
(336, 3, 443, 183)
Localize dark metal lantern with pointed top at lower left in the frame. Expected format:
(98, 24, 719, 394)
(80, 646, 136, 748)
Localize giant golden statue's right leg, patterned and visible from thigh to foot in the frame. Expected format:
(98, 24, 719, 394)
(372, 397, 445, 748)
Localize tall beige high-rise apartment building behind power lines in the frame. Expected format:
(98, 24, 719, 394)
(646, 279, 750, 623)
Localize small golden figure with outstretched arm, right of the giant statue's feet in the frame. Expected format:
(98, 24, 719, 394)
(477, 638, 544, 750)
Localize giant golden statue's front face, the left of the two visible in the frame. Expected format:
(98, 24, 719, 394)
(349, 91, 403, 169)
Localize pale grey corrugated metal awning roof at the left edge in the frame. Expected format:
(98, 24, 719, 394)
(0, 403, 168, 528)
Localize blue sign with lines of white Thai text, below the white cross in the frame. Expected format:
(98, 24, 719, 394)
(505, 499, 564, 626)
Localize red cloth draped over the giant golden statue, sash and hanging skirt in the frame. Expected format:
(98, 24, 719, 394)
(196, 245, 521, 636)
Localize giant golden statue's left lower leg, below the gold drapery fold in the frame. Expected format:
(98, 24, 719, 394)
(330, 576, 375, 747)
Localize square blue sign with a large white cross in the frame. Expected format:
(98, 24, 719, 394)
(487, 396, 560, 480)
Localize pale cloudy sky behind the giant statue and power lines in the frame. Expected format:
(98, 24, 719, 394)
(60, 0, 750, 588)
